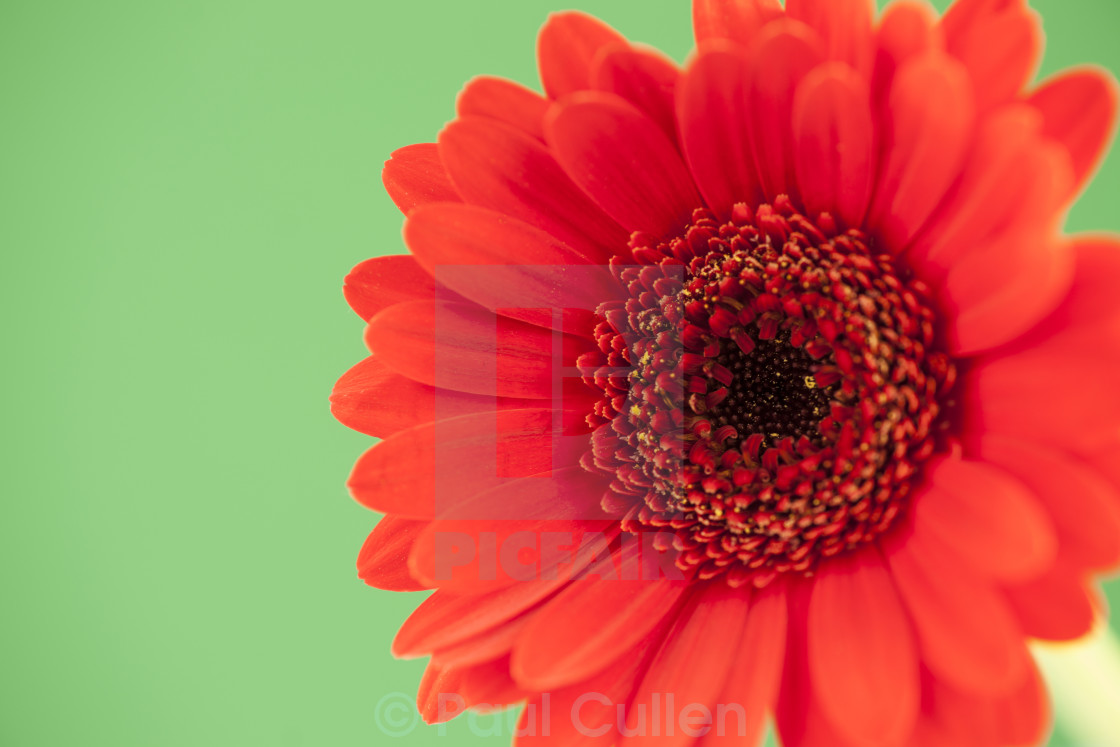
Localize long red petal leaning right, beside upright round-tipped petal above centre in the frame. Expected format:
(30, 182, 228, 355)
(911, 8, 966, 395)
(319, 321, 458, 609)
(868, 53, 974, 252)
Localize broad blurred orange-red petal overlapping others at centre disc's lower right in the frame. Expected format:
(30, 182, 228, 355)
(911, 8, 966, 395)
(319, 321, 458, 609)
(913, 458, 1057, 581)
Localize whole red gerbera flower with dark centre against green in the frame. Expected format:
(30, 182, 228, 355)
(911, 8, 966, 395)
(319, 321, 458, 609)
(333, 0, 1120, 747)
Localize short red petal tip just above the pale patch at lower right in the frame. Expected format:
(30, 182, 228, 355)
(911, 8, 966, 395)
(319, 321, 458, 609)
(1006, 568, 1096, 641)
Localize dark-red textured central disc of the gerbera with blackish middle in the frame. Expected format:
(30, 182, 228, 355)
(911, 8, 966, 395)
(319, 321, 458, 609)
(580, 198, 954, 587)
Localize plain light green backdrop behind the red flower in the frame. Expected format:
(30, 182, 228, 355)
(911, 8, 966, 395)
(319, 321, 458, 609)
(0, 0, 1120, 747)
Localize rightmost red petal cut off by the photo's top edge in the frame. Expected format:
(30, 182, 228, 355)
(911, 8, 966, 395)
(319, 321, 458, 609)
(941, 0, 1043, 110)
